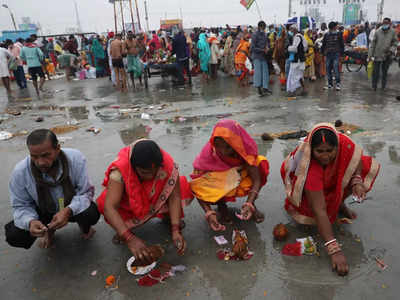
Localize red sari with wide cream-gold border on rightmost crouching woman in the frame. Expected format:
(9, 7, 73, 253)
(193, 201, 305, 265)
(281, 123, 380, 225)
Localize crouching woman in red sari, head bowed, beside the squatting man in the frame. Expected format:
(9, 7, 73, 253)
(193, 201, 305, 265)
(97, 140, 193, 262)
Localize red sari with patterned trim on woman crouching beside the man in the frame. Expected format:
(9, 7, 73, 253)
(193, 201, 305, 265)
(97, 145, 193, 228)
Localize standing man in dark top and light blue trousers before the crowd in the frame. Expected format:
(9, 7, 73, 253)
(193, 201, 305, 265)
(250, 21, 272, 96)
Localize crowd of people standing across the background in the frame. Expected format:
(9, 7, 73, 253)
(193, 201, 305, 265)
(0, 18, 400, 96)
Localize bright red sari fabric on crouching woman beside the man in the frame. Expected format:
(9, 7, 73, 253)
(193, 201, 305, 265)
(97, 146, 193, 220)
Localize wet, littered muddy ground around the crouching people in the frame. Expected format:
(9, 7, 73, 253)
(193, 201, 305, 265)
(0, 66, 400, 300)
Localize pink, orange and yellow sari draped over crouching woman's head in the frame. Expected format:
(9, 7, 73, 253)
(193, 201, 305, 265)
(190, 120, 269, 203)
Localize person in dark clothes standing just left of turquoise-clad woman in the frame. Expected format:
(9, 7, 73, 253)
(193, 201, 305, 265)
(172, 30, 192, 84)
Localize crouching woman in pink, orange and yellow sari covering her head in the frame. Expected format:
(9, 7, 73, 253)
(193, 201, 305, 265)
(190, 120, 269, 231)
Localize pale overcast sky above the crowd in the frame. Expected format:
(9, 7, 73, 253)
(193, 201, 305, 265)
(0, 0, 400, 34)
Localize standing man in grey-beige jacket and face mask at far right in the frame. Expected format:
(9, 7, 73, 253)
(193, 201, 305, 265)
(368, 18, 397, 91)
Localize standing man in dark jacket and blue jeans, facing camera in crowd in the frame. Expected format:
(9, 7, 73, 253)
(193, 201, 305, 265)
(321, 22, 344, 91)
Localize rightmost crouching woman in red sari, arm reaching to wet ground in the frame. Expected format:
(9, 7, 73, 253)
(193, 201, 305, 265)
(281, 123, 380, 276)
